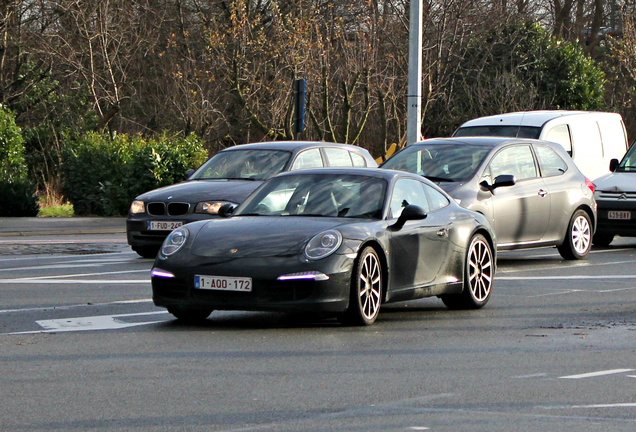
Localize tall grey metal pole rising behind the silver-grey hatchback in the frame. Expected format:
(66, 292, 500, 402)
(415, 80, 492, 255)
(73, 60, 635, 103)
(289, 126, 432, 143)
(406, 0, 423, 145)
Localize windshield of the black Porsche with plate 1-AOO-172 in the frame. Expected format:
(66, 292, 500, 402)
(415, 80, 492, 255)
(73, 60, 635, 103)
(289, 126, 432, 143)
(236, 174, 386, 219)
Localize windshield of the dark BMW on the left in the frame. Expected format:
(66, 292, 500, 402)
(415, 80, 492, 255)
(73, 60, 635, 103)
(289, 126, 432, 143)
(190, 150, 291, 180)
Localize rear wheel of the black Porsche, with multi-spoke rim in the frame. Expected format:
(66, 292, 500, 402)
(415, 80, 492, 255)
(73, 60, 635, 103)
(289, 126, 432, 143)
(441, 234, 495, 309)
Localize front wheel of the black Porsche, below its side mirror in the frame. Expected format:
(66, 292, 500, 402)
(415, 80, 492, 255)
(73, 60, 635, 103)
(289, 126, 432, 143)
(340, 246, 383, 326)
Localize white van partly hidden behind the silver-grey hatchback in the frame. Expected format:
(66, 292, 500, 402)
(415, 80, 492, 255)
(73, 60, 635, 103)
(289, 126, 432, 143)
(453, 111, 628, 180)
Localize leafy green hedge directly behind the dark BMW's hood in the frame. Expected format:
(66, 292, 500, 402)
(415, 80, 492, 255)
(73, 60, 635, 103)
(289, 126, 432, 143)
(62, 133, 207, 216)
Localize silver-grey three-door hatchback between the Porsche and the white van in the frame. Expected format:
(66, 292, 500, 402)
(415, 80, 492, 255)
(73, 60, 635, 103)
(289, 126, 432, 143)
(381, 137, 597, 259)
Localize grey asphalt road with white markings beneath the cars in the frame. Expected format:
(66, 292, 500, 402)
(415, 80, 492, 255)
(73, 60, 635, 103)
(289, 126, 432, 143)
(0, 221, 636, 432)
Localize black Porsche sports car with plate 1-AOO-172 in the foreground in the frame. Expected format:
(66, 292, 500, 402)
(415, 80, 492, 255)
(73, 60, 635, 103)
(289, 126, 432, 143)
(152, 168, 496, 325)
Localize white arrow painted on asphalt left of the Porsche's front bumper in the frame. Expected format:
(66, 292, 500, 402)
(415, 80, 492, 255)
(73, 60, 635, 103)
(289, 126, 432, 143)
(5, 311, 168, 335)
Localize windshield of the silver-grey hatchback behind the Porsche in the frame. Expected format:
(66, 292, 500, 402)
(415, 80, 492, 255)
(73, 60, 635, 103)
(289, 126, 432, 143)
(382, 144, 492, 182)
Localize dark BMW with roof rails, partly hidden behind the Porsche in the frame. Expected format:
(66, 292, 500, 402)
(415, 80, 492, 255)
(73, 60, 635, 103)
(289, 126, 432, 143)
(126, 141, 377, 258)
